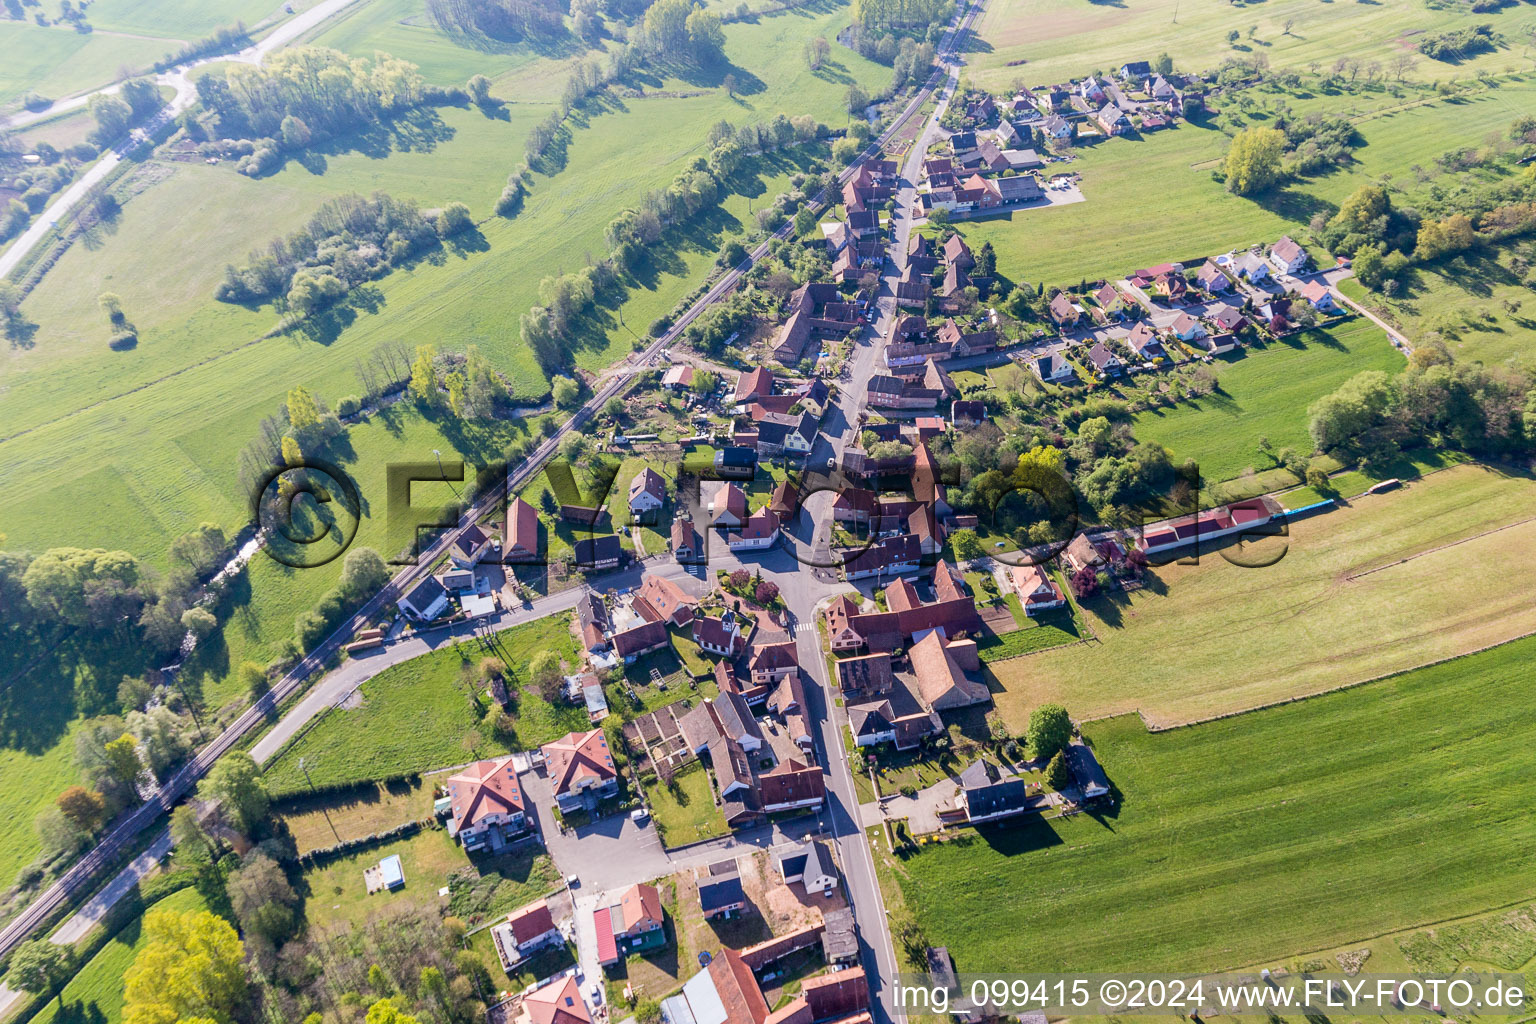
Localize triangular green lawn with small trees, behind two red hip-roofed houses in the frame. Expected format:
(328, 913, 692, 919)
(267, 614, 588, 795)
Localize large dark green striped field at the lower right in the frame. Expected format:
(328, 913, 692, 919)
(877, 639, 1536, 972)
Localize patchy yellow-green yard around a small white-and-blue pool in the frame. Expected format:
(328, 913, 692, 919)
(304, 829, 559, 927)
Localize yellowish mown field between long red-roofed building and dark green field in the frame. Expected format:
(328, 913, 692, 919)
(989, 465, 1536, 734)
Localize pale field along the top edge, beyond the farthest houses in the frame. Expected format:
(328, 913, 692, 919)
(968, 0, 1536, 91)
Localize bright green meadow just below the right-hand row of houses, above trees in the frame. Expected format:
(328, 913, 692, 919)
(1134, 318, 1402, 484)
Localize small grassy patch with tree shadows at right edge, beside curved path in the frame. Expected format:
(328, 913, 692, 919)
(1341, 249, 1536, 365)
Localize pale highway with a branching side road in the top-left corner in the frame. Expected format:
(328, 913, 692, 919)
(0, 0, 356, 280)
